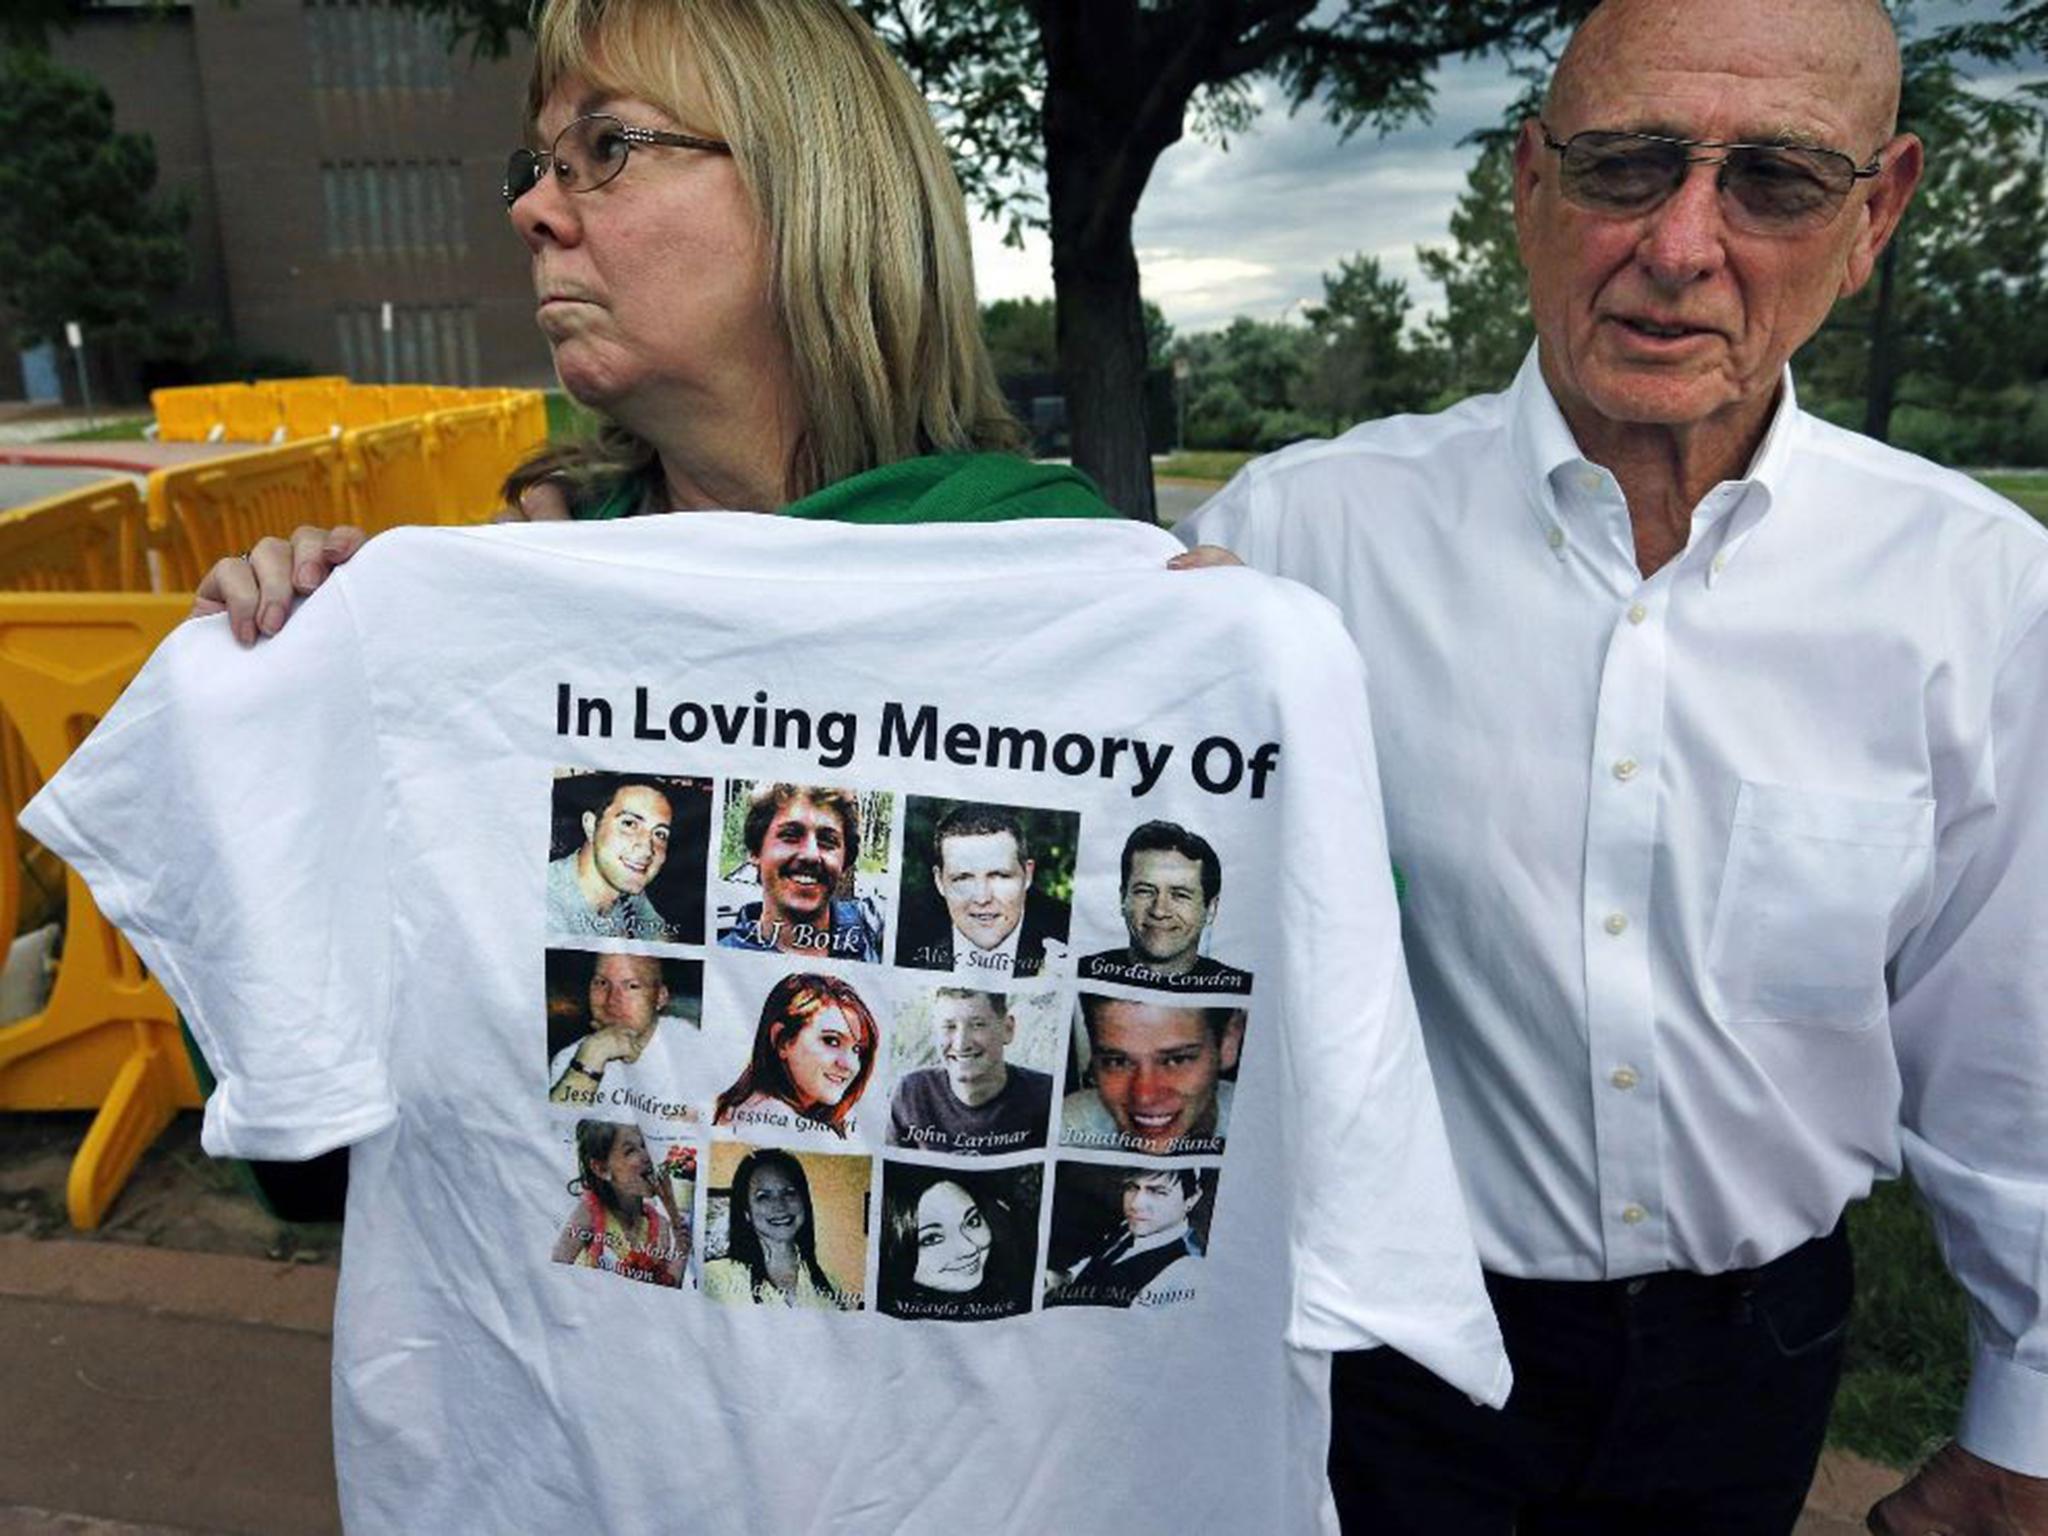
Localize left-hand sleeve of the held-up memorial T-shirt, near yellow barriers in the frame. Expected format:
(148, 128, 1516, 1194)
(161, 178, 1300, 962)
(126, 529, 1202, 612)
(20, 582, 395, 1159)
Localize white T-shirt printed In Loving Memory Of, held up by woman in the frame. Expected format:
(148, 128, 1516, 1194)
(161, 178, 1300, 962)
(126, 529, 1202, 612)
(23, 514, 1507, 1536)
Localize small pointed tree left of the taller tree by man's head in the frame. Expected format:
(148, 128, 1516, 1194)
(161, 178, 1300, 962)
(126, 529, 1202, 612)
(1300, 254, 1432, 432)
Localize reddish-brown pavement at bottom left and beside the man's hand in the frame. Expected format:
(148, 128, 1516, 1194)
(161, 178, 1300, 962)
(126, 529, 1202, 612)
(0, 1237, 1901, 1536)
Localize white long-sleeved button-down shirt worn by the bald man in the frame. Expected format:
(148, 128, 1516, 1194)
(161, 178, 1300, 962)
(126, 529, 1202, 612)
(1182, 352, 2048, 1475)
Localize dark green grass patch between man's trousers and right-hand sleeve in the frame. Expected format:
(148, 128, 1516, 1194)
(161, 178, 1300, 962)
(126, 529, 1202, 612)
(1827, 1184, 1970, 1466)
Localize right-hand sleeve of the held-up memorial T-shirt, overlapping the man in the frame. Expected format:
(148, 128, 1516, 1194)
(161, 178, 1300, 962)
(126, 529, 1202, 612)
(1272, 590, 1511, 1407)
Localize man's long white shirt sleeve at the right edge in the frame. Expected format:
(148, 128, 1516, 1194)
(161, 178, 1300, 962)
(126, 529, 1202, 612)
(1890, 569, 2048, 1477)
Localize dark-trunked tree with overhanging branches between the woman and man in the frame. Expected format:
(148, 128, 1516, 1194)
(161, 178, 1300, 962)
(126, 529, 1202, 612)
(387, 0, 1591, 518)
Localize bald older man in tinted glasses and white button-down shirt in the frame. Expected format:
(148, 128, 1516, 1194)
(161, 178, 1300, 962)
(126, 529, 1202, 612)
(1192, 0, 2048, 1536)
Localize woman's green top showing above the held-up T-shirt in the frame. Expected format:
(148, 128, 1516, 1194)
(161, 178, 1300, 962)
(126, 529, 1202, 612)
(575, 453, 1116, 522)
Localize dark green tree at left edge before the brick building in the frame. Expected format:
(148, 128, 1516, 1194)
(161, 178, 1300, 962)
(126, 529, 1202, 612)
(0, 49, 186, 360)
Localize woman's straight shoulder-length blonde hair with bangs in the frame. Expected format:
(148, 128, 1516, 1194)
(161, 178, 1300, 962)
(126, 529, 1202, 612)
(510, 0, 1022, 512)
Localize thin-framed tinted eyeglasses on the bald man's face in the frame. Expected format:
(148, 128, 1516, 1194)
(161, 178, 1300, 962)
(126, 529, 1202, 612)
(1536, 123, 1884, 236)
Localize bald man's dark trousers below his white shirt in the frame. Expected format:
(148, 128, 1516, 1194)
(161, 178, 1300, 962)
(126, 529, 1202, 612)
(1329, 1227, 1855, 1536)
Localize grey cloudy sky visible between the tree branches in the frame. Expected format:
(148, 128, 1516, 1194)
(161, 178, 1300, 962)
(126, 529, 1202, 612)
(975, 0, 2039, 332)
